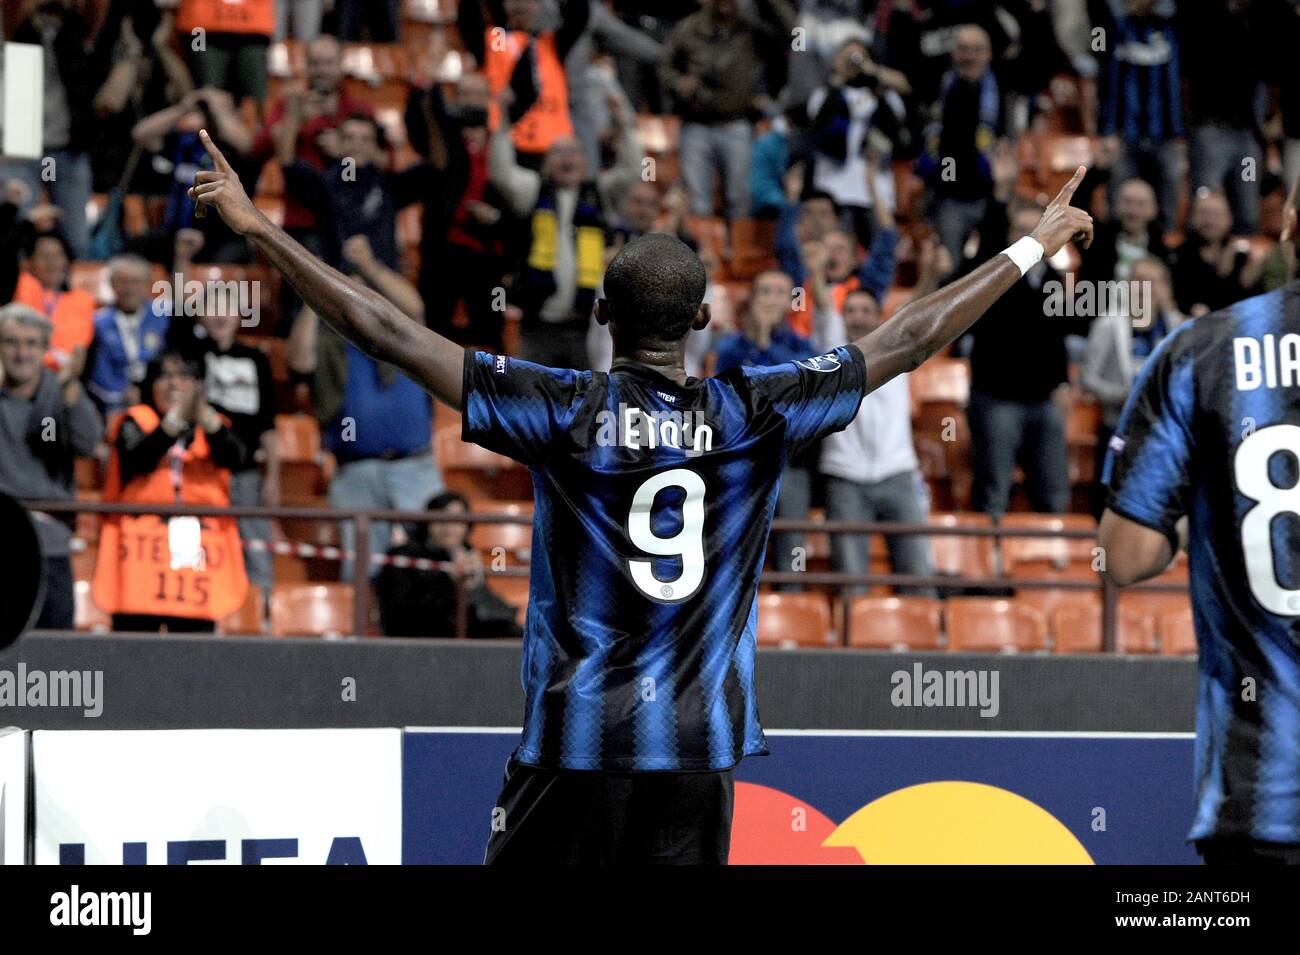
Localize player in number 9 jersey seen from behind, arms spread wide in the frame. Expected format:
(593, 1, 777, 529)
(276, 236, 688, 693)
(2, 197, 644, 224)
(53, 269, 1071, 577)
(192, 134, 1092, 863)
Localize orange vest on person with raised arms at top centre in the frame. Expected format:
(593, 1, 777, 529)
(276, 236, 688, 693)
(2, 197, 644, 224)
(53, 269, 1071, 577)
(484, 27, 573, 153)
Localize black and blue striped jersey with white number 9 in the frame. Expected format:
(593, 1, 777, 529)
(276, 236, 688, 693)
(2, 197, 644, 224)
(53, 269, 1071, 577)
(462, 346, 866, 770)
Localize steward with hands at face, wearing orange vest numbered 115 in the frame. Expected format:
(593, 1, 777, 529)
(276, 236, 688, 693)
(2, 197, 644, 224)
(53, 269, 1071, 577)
(91, 352, 248, 631)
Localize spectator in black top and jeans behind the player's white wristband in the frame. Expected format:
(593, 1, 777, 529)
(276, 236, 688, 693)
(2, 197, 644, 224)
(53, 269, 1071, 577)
(962, 149, 1089, 516)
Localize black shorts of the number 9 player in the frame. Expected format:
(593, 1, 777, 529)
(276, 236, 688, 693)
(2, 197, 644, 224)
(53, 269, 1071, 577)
(484, 756, 736, 865)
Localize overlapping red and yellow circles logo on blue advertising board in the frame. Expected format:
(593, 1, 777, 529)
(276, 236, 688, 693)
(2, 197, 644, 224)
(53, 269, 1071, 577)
(731, 781, 1092, 865)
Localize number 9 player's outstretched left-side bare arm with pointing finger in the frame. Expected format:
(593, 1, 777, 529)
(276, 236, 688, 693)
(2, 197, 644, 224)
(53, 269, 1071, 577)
(190, 130, 464, 409)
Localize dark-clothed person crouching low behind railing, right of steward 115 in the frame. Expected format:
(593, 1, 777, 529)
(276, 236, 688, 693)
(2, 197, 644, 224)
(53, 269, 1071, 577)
(374, 491, 521, 638)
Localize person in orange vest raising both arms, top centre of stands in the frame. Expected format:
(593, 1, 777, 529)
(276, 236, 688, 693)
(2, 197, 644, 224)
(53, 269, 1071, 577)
(456, 0, 590, 169)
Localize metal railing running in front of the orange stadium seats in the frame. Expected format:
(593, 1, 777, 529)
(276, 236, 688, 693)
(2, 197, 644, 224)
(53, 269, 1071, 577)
(22, 500, 1187, 652)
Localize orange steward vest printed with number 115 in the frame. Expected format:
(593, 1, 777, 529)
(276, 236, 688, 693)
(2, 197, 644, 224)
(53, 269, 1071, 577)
(91, 404, 248, 620)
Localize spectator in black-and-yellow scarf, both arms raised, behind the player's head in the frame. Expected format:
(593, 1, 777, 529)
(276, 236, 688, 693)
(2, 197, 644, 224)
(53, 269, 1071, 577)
(489, 89, 642, 369)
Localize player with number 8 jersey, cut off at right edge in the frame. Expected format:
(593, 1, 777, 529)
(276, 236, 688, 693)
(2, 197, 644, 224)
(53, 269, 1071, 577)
(1099, 183, 1300, 864)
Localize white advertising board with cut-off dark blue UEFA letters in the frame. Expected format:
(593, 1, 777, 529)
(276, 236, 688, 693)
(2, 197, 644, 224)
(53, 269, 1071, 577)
(33, 729, 402, 865)
